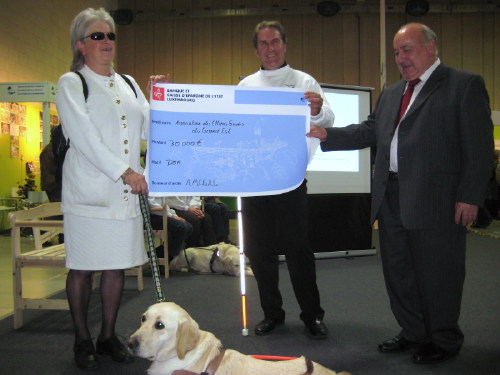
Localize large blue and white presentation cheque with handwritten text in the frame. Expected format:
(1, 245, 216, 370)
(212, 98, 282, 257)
(147, 84, 310, 196)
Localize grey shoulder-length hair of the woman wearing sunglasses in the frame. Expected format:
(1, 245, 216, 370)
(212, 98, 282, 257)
(69, 8, 115, 72)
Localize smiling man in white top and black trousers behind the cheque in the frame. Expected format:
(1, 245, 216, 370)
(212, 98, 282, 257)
(240, 21, 333, 339)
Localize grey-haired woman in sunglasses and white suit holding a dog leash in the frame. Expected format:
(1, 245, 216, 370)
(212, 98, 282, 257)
(56, 8, 166, 370)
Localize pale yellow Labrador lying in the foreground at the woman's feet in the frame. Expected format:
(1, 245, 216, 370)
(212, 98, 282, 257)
(127, 302, 347, 375)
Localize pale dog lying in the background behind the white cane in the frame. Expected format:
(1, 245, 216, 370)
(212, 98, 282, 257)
(169, 242, 253, 276)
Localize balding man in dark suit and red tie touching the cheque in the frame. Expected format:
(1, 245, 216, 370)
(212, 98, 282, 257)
(308, 23, 493, 363)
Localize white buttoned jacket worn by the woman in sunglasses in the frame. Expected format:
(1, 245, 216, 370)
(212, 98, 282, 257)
(56, 66, 149, 220)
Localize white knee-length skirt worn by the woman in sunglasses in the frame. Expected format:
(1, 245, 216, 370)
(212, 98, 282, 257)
(64, 214, 148, 271)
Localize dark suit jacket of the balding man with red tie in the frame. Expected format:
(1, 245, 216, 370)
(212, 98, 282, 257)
(321, 64, 494, 229)
